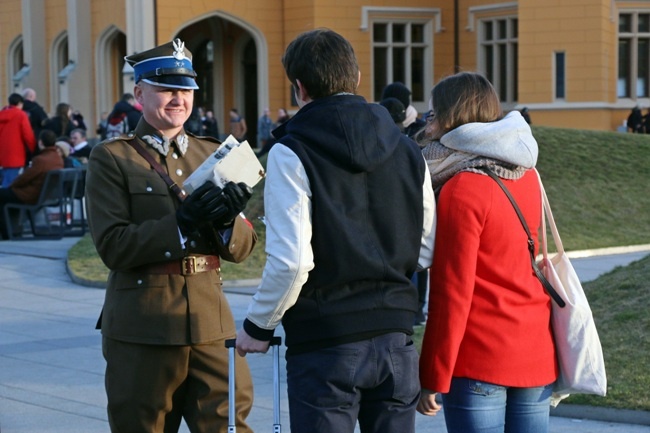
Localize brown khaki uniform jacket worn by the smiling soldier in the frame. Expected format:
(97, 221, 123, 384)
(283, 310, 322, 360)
(86, 119, 257, 345)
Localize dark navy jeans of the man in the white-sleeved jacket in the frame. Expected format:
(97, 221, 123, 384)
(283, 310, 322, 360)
(287, 333, 420, 433)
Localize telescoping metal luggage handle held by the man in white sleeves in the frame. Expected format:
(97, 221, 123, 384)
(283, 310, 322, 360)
(226, 337, 282, 433)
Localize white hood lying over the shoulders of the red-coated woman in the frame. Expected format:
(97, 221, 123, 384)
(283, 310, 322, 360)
(440, 111, 539, 168)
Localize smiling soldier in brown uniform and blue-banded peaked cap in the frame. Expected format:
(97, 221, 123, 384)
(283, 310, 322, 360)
(86, 39, 257, 433)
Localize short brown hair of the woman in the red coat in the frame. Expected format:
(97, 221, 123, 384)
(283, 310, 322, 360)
(431, 72, 503, 132)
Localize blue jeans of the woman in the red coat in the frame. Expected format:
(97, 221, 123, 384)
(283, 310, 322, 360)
(442, 377, 553, 433)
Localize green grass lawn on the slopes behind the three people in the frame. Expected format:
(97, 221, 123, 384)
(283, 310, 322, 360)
(68, 126, 650, 410)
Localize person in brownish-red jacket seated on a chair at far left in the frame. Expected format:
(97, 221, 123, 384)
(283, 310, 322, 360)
(0, 130, 63, 239)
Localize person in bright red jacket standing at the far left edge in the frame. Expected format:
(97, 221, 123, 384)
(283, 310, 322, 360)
(0, 93, 36, 188)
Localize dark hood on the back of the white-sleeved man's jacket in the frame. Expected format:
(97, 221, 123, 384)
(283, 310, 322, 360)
(273, 94, 402, 172)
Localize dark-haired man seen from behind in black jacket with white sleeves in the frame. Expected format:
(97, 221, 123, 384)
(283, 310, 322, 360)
(237, 29, 435, 433)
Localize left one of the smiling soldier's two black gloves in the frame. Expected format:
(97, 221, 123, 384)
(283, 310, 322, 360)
(176, 181, 228, 236)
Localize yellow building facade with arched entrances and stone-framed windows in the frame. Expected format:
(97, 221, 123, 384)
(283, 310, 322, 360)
(0, 0, 650, 139)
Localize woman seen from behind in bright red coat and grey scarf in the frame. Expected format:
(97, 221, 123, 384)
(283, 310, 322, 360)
(418, 72, 557, 433)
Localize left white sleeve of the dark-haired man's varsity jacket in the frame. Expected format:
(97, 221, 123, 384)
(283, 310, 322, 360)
(247, 143, 314, 329)
